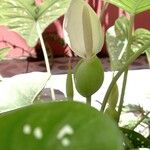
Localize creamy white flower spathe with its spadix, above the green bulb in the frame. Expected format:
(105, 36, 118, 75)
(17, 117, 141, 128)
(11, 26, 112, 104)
(63, 0, 104, 58)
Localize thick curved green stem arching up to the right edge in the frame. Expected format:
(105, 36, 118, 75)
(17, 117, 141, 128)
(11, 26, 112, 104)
(101, 41, 150, 111)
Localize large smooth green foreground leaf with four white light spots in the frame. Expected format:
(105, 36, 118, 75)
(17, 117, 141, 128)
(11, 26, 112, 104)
(0, 101, 123, 150)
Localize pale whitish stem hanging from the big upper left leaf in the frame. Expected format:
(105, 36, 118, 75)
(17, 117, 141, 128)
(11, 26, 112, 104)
(36, 22, 56, 100)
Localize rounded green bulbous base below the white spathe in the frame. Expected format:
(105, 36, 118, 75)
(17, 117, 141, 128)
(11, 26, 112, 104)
(74, 56, 104, 97)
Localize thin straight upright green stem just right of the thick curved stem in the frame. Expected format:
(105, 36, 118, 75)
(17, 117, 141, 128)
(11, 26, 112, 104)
(117, 69, 128, 123)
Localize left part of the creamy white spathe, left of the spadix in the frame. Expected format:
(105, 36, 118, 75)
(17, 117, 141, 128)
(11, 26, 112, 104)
(63, 0, 86, 57)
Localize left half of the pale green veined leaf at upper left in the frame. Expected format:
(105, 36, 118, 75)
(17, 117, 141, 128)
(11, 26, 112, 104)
(0, 0, 37, 46)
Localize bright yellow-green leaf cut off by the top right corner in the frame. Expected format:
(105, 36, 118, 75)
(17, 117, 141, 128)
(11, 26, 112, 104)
(106, 0, 150, 15)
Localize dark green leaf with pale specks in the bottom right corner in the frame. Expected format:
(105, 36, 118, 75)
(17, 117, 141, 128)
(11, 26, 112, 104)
(121, 128, 150, 148)
